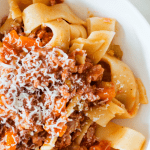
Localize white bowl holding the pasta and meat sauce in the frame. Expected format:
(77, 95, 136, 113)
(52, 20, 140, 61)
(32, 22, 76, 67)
(0, 0, 150, 150)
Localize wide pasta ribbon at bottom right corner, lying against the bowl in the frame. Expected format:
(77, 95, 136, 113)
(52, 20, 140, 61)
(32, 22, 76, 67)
(95, 122, 145, 150)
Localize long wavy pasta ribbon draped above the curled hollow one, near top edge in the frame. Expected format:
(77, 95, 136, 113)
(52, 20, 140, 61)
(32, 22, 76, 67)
(23, 3, 85, 33)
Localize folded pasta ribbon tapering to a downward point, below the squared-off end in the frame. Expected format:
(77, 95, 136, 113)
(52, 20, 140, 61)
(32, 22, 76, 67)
(71, 31, 115, 64)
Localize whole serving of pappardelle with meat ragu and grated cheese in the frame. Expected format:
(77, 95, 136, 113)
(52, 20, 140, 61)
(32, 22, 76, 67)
(0, 0, 148, 150)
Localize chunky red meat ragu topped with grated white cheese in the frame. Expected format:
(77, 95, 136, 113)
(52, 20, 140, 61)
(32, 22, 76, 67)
(0, 29, 114, 150)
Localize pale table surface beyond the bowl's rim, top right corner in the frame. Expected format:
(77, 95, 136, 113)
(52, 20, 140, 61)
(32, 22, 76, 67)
(129, 0, 150, 24)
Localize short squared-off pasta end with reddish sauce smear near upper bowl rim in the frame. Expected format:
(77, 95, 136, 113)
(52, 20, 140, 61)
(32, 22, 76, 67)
(87, 17, 116, 35)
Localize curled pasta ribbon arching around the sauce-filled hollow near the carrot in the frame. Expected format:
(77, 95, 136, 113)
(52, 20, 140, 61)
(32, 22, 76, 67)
(42, 19, 87, 52)
